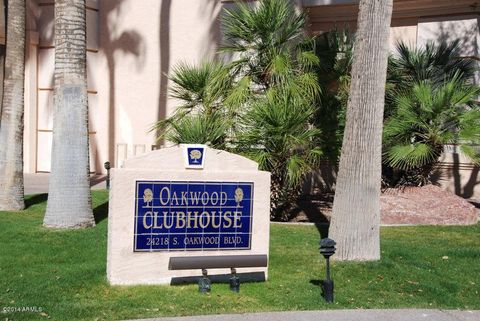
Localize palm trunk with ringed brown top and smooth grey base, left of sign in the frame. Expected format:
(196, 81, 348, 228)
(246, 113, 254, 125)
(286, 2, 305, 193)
(44, 0, 95, 228)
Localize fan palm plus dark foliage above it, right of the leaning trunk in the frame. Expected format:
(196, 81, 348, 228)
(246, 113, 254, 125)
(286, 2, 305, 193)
(383, 41, 478, 185)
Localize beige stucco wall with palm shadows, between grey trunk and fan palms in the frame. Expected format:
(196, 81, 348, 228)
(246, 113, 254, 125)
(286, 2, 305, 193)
(97, 0, 225, 166)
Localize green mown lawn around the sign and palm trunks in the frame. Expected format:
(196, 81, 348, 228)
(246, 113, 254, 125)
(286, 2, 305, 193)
(0, 191, 480, 320)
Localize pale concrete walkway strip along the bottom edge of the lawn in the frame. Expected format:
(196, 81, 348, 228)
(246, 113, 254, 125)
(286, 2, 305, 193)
(124, 309, 480, 321)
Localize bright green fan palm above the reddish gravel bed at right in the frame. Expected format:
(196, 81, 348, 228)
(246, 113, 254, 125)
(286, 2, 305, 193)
(384, 73, 480, 186)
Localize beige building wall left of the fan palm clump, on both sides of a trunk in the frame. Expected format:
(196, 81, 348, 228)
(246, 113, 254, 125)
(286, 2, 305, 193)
(25, 0, 223, 173)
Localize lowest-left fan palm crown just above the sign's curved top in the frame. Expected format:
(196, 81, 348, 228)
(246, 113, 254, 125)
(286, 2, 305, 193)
(152, 61, 232, 149)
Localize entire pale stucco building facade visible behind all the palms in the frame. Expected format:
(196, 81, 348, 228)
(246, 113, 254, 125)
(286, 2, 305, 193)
(21, 0, 480, 198)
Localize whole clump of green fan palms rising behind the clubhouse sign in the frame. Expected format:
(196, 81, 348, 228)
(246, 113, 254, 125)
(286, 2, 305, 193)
(156, 0, 321, 220)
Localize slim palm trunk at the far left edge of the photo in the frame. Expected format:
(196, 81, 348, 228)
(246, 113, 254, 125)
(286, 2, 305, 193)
(0, 0, 25, 210)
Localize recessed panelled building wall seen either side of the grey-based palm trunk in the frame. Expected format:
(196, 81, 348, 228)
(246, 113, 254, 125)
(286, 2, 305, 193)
(24, 0, 100, 172)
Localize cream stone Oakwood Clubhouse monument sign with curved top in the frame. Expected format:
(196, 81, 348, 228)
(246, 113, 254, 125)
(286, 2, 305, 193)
(107, 145, 270, 285)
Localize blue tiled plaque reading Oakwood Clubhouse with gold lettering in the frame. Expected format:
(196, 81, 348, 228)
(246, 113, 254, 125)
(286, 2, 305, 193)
(134, 181, 253, 252)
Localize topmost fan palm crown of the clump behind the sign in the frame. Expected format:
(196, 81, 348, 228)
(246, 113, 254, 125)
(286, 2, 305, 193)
(220, 0, 318, 93)
